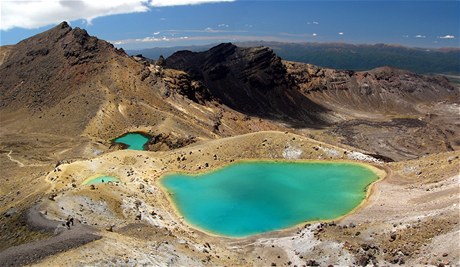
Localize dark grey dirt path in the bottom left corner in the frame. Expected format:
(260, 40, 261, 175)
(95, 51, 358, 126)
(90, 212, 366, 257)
(0, 207, 101, 266)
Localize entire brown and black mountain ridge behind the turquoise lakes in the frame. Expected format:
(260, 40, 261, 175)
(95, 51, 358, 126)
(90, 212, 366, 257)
(0, 23, 460, 160)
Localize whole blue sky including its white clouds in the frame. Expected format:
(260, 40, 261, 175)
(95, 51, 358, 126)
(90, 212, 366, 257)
(0, 0, 460, 49)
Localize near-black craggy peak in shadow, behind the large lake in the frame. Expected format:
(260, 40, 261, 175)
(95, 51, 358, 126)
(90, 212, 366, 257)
(166, 43, 327, 126)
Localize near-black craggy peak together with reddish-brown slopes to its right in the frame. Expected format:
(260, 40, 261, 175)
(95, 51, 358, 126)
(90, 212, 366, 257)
(165, 44, 460, 160)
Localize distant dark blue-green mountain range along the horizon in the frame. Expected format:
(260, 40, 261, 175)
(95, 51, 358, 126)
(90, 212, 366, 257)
(127, 41, 460, 75)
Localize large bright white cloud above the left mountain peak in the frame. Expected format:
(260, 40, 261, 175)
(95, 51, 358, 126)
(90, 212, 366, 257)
(0, 0, 232, 30)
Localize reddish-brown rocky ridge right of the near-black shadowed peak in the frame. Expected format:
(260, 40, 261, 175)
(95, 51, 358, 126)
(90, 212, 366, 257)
(284, 62, 460, 114)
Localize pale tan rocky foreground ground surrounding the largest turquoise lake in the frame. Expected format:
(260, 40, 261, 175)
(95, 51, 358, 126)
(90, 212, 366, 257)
(0, 132, 460, 266)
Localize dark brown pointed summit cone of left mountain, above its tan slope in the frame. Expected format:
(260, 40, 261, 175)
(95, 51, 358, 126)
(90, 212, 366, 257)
(0, 22, 126, 110)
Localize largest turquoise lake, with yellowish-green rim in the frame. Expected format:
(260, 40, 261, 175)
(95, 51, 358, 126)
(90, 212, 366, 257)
(161, 162, 378, 237)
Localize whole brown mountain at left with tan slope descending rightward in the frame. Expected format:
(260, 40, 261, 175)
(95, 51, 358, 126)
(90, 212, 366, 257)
(0, 23, 284, 142)
